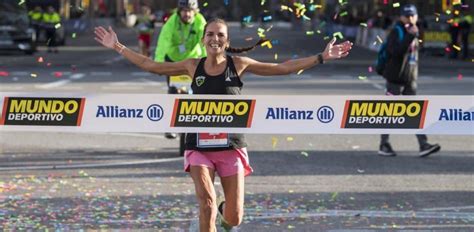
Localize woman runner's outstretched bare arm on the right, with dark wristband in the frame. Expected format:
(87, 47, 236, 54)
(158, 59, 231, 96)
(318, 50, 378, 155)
(240, 38, 352, 76)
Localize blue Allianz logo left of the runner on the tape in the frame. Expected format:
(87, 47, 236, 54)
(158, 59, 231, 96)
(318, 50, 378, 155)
(95, 104, 164, 122)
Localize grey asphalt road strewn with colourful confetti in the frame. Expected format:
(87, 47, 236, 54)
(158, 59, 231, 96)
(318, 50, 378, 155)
(0, 23, 474, 231)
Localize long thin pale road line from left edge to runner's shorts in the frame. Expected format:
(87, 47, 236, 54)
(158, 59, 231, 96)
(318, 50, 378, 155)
(0, 157, 183, 171)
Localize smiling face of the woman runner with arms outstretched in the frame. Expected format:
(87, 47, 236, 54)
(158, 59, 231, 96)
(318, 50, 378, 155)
(203, 22, 229, 55)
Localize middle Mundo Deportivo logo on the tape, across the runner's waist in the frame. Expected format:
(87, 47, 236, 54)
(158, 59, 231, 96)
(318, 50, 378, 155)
(171, 99, 256, 128)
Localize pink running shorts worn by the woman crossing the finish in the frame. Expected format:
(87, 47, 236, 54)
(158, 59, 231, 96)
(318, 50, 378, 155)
(184, 147, 253, 177)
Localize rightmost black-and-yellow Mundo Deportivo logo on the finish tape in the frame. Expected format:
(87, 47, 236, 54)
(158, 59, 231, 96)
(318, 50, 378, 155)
(341, 100, 428, 129)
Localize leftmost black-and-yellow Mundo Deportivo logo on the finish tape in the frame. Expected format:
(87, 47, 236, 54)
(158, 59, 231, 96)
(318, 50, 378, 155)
(0, 97, 85, 126)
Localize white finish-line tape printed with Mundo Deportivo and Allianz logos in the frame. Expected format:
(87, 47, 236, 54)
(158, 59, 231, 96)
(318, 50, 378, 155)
(0, 93, 474, 135)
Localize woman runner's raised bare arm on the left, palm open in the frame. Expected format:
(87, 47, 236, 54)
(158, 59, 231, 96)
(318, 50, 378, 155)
(94, 26, 194, 76)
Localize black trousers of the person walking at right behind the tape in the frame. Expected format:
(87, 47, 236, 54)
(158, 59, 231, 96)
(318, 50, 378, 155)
(380, 78, 428, 147)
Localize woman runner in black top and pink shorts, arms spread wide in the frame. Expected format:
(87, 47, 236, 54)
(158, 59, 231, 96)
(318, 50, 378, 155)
(95, 19, 352, 231)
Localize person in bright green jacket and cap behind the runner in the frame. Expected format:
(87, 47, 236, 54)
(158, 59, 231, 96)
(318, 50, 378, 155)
(155, 0, 206, 139)
